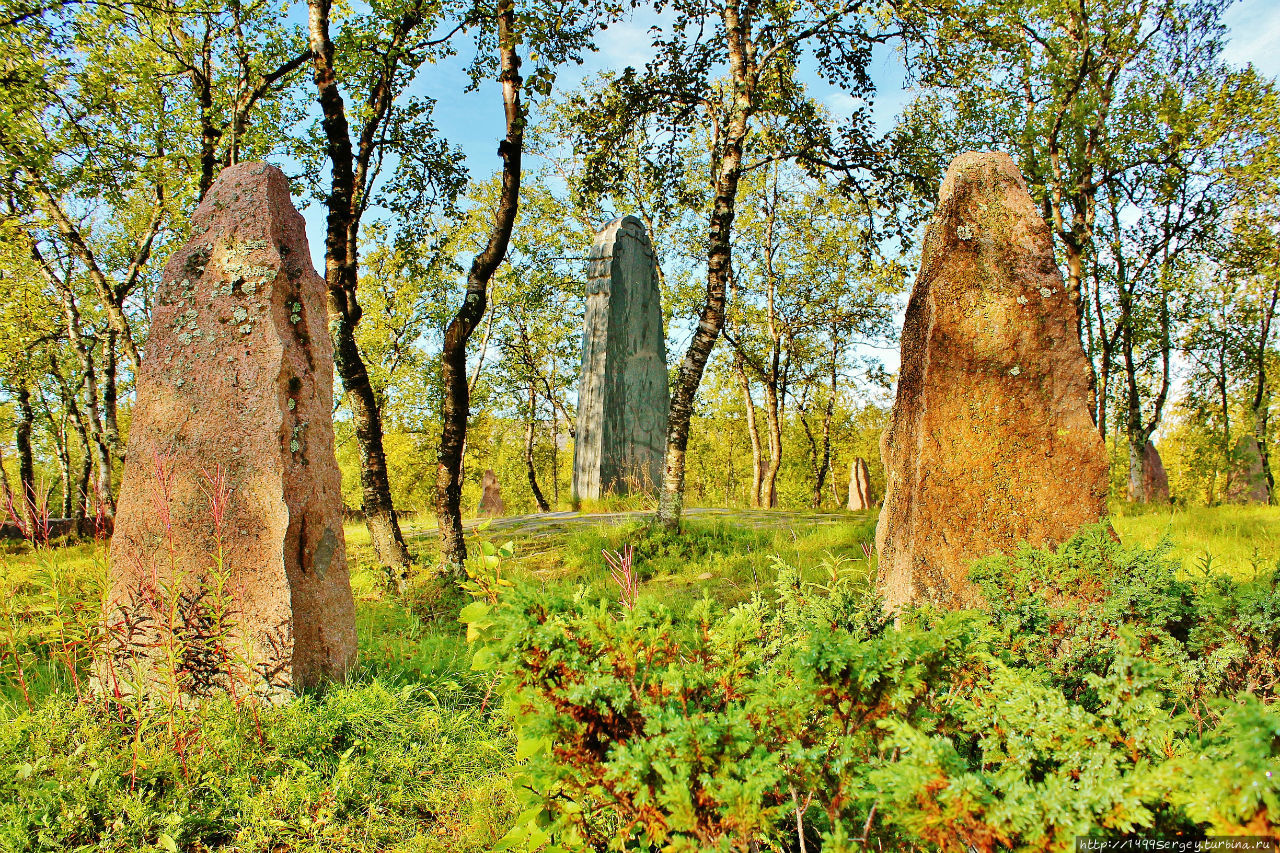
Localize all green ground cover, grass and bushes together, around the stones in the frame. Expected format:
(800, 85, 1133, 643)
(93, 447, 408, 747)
(0, 507, 1280, 853)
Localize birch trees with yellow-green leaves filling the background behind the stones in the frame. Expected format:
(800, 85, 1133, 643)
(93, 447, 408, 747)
(0, 0, 1280, 578)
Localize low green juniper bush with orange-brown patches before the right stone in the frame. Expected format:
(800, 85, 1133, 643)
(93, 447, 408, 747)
(463, 528, 1280, 850)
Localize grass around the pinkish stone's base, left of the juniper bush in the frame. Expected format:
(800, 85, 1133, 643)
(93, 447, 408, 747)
(0, 529, 518, 853)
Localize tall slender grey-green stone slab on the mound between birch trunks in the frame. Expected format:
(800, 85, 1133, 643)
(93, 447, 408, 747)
(573, 216, 669, 500)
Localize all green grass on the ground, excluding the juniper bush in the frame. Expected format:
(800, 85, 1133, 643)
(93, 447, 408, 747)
(0, 507, 1280, 853)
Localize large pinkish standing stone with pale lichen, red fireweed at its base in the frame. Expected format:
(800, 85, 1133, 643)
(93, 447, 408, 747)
(99, 163, 356, 697)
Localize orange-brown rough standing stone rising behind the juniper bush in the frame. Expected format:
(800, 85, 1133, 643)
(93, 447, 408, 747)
(876, 152, 1107, 608)
